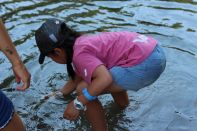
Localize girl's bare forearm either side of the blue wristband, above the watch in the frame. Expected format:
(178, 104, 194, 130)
(78, 65, 112, 105)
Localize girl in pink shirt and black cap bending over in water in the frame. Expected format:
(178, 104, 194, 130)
(35, 19, 166, 131)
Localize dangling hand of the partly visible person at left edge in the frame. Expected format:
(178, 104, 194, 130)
(12, 63, 31, 91)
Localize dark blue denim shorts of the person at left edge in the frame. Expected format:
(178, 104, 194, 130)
(0, 90, 14, 129)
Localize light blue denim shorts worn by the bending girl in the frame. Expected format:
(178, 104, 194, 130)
(110, 44, 166, 91)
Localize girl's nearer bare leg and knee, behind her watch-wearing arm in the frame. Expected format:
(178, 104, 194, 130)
(77, 81, 108, 131)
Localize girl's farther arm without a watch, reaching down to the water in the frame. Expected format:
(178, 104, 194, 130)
(60, 75, 82, 95)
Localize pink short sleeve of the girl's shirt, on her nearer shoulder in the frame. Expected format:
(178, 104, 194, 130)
(73, 53, 103, 84)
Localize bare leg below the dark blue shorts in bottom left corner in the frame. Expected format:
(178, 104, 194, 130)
(1, 112, 25, 131)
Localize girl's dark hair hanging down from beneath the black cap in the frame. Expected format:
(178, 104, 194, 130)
(60, 23, 81, 80)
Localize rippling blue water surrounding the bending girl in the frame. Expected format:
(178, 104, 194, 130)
(0, 0, 197, 131)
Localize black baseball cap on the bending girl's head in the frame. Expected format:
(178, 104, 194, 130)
(35, 19, 65, 64)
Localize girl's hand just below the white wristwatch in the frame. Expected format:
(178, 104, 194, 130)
(63, 101, 80, 120)
